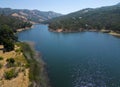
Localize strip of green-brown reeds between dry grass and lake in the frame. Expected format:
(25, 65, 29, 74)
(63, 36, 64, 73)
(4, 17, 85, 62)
(20, 42, 51, 87)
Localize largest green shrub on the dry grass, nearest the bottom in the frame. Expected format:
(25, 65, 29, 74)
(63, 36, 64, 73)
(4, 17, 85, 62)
(4, 69, 18, 80)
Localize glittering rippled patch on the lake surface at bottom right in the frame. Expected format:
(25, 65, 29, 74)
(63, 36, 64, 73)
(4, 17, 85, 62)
(71, 56, 109, 87)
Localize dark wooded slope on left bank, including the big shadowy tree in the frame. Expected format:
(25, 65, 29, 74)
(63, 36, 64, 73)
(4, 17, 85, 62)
(0, 15, 32, 51)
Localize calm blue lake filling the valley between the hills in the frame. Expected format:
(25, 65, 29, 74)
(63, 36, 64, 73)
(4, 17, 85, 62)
(18, 25, 120, 87)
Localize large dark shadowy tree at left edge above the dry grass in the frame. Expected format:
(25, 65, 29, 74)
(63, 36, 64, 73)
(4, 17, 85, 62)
(0, 25, 17, 51)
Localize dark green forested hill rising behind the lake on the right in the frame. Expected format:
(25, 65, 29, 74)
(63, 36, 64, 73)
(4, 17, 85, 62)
(46, 3, 120, 31)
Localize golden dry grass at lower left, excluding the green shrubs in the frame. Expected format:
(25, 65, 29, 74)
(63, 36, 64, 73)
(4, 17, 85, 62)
(0, 46, 30, 87)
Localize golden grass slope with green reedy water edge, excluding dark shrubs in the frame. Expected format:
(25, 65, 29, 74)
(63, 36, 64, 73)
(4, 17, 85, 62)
(0, 43, 50, 87)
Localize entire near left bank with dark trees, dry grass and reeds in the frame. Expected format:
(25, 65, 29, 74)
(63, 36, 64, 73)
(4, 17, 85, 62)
(0, 15, 49, 87)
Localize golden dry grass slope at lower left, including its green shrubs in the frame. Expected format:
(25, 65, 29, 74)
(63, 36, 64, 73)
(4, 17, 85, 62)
(0, 45, 30, 87)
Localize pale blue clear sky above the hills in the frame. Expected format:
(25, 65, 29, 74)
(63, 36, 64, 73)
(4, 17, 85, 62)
(0, 0, 120, 14)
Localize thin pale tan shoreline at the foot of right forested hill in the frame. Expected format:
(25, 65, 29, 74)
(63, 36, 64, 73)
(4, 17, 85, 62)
(49, 29, 120, 37)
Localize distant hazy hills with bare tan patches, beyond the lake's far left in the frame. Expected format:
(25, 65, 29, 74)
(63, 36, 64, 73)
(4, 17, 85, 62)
(0, 8, 62, 23)
